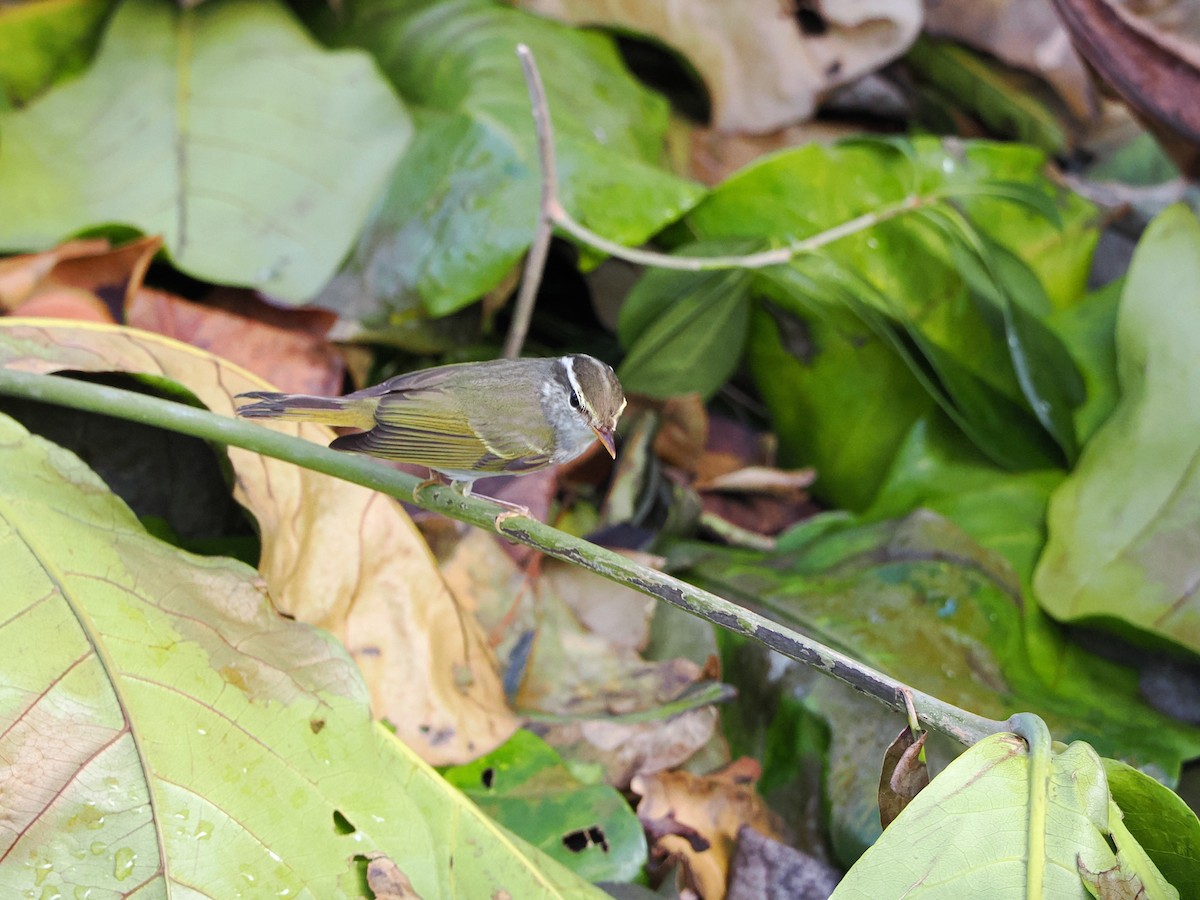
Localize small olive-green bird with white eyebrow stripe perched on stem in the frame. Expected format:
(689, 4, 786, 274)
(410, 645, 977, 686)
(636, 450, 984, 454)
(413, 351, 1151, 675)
(238, 354, 625, 493)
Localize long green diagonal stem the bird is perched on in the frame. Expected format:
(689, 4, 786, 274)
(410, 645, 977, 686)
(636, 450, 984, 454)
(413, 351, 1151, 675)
(0, 367, 1007, 745)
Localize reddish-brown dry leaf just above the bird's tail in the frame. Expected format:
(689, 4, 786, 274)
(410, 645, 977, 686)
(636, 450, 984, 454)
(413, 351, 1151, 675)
(125, 288, 344, 396)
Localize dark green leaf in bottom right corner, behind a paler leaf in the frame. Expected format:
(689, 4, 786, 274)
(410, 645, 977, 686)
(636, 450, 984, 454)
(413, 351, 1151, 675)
(1104, 760, 1200, 896)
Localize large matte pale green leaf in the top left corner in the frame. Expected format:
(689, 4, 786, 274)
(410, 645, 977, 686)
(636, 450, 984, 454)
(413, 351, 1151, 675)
(0, 0, 412, 301)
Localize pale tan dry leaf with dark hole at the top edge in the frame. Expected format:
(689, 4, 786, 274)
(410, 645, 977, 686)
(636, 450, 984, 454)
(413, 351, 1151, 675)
(518, 0, 923, 133)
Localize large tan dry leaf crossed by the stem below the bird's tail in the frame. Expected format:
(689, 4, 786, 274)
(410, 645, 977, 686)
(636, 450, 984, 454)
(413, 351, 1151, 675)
(0, 319, 516, 764)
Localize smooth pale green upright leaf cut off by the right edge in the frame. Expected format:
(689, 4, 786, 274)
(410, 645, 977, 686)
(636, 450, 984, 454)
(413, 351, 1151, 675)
(1034, 206, 1200, 650)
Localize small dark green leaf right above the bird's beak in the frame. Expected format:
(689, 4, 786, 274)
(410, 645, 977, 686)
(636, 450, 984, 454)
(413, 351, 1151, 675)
(617, 242, 754, 400)
